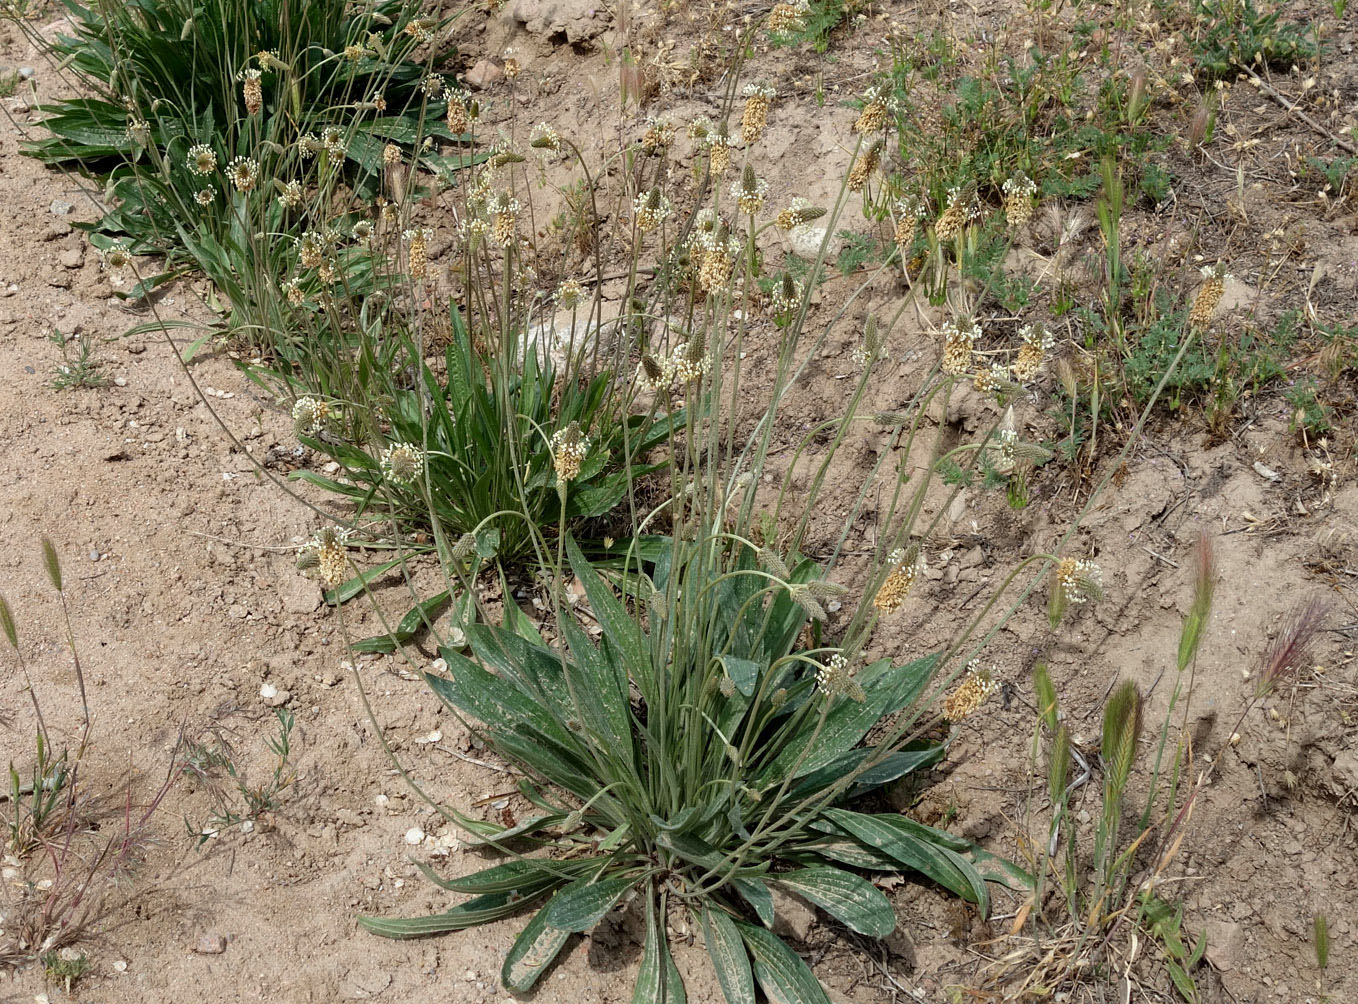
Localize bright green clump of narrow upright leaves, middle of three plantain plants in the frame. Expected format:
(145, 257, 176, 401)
(292, 306, 684, 564)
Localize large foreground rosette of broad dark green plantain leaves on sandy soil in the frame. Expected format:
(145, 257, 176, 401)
(360, 534, 1024, 1003)
